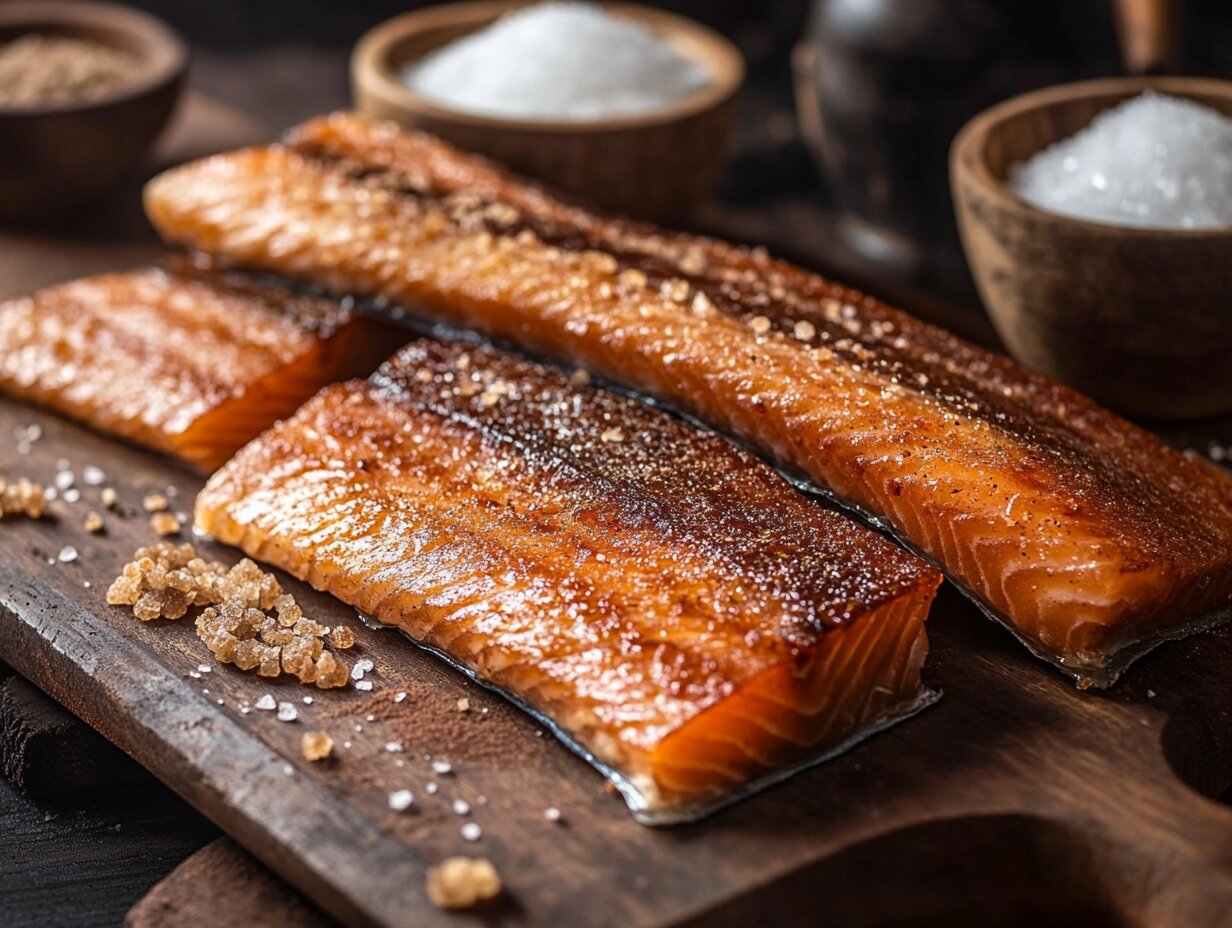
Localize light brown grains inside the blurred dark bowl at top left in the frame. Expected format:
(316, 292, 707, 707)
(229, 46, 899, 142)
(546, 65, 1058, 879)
(0, 33, 140, 107)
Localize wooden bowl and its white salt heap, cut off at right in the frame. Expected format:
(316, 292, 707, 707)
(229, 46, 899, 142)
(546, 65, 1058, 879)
(950, 78, 1232, 419)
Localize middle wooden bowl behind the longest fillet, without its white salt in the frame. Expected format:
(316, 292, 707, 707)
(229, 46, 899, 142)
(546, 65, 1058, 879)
(351, 0, 744, 219)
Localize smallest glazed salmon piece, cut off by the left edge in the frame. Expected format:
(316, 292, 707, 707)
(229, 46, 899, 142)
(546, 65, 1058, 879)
(0, 260, 391, 471)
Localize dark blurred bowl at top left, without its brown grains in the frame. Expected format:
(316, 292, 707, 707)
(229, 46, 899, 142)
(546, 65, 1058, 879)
(0, 0, 188, 222)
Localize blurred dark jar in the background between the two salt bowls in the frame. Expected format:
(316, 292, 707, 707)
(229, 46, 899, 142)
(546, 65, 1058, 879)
(793, 0, 1119, 277)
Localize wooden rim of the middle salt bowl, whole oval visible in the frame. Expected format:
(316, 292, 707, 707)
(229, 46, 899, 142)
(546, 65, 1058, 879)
(351, 0, 745, 134)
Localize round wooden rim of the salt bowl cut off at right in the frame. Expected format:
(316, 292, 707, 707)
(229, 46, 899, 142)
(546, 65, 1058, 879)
(950, 76, 1232, 242)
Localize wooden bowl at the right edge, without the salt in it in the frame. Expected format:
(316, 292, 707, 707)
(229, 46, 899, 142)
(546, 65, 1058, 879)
(950, 78, 1232, 419)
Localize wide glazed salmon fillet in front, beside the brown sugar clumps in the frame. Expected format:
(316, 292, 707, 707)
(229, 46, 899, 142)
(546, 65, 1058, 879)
(196, 340, 941, 822)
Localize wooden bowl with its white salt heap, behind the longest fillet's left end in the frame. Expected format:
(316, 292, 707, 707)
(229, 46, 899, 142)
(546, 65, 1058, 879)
(351, 1, 744, 219)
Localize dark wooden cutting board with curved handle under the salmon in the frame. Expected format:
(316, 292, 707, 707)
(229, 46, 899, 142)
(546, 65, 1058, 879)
(0, 92, 1232, 928)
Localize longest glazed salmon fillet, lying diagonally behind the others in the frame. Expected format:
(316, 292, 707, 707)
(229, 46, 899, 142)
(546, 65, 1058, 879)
(147, 115, 1232, 685)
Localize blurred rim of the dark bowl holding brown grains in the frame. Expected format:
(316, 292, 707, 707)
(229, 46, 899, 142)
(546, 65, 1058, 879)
(0, 0, 188, 120)
